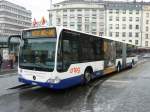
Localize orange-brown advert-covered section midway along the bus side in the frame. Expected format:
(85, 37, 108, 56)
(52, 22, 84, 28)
(104, 40, 116, 74)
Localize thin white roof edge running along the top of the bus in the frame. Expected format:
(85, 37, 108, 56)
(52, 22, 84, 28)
(22, 26, 136, 46)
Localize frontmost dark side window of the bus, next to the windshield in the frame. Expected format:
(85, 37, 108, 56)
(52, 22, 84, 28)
(58, 31, 79, 72)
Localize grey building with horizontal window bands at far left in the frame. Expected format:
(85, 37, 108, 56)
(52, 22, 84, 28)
(0, 0, 32, 37)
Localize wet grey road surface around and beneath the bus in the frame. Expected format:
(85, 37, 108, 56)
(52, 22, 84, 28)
(0, 61, 150, 112)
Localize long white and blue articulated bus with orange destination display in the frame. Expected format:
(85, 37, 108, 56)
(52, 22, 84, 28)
(9, 27, 138, 89)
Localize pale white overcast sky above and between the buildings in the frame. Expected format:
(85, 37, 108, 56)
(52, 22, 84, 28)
(7, 0, 150, 21)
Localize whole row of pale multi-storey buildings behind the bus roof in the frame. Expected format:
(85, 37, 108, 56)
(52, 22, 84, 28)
(49, 0, 150, 47)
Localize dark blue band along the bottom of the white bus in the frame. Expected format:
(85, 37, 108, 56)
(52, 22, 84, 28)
(18, 71, 103, 89)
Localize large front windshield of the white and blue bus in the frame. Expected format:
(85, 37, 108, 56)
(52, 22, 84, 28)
(19, 37, 56, 72)
